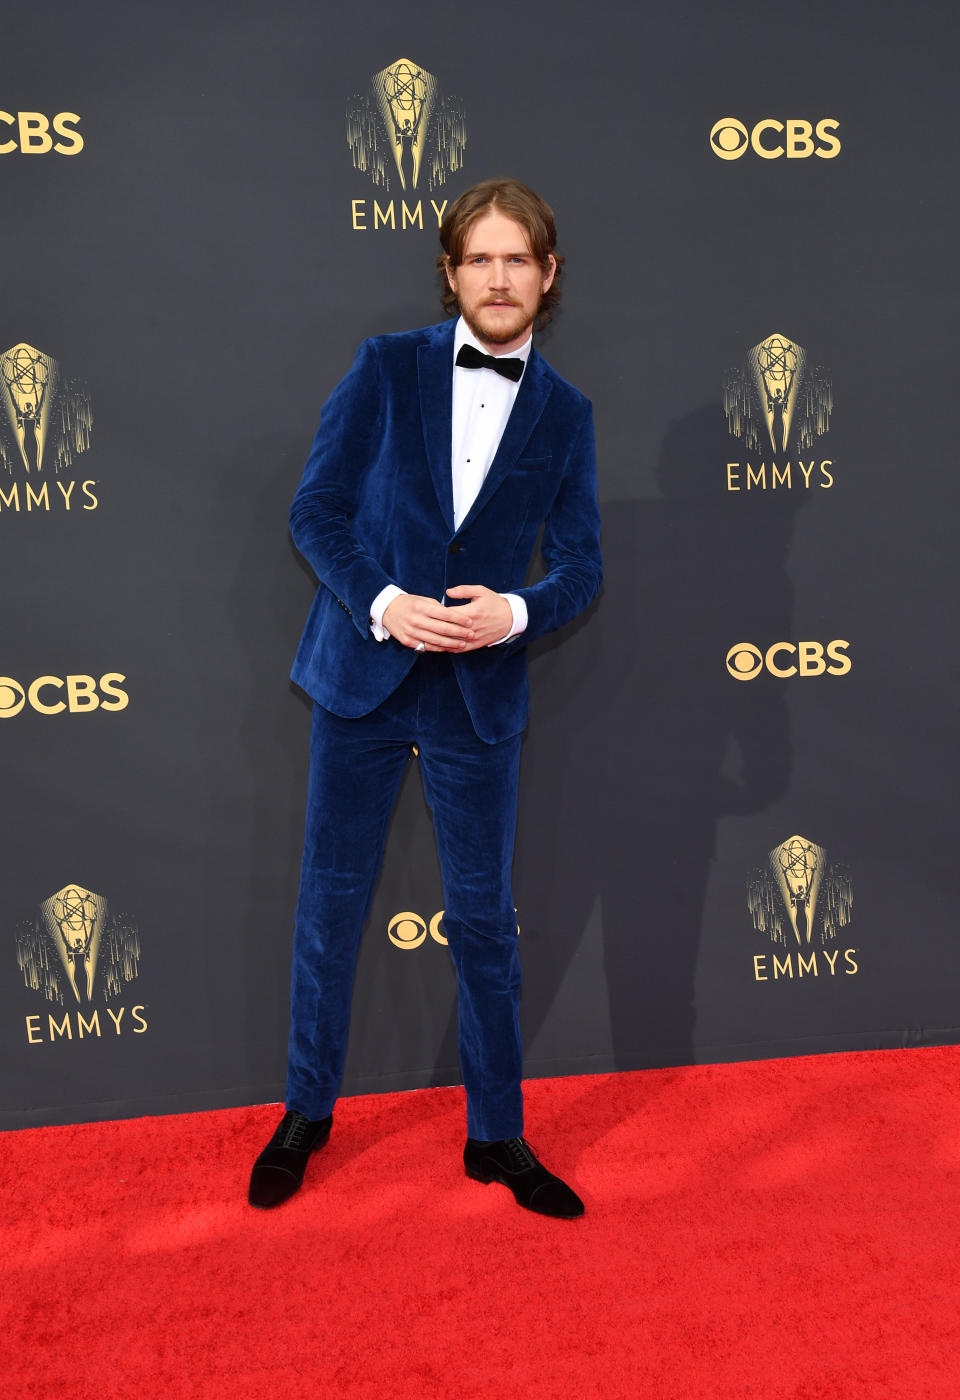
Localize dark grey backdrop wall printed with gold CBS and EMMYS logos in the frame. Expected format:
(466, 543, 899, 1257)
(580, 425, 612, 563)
(0, 0, 959, 1127)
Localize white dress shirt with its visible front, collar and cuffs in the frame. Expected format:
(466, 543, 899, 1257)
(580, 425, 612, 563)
(369, 316, 533, 645)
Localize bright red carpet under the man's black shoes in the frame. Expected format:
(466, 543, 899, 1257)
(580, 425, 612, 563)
(0, 1047, 960, 1400)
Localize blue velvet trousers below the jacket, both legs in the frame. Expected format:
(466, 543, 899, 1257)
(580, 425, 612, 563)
(287, 652, 523, 1140)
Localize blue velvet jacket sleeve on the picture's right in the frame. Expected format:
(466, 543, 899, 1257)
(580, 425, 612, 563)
(507, 403, 603, 645)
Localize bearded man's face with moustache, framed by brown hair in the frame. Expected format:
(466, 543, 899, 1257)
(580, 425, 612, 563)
(446, 209, 557, 354)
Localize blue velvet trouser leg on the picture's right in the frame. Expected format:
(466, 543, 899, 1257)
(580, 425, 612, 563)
(420, 668, 523, 1140)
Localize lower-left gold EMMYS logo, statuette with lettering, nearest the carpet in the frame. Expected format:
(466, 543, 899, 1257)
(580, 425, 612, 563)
(17, 883, 147, 1044)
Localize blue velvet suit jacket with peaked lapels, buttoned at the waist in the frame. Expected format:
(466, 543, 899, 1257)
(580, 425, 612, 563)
(290, 321, 602, 743)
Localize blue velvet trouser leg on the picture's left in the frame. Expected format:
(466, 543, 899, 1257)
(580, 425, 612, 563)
(285, 706, 410, 1120)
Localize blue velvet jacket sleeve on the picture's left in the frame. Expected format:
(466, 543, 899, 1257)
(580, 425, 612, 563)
(290, 340, 396, 637)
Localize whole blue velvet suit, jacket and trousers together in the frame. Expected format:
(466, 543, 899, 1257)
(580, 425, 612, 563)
(287, 321, 600, 1140)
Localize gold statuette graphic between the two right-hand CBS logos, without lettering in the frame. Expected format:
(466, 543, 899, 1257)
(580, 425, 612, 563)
(723, 333, 833, 461)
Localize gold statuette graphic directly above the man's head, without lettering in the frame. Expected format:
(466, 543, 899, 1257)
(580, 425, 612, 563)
(347, 59, 466, 195)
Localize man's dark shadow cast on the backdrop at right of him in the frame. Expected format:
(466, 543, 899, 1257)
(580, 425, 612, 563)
(515, 405, 798, 1074)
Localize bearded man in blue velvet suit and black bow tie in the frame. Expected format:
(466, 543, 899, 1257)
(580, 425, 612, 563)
(249, 179, 600, 1218)
